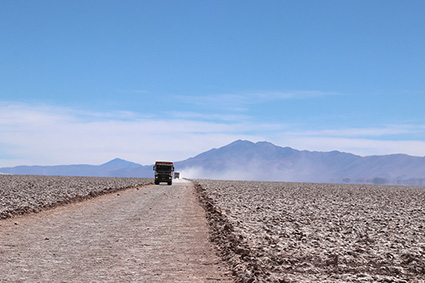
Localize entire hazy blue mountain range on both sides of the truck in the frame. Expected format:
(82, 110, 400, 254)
(0, 140, 425, 185)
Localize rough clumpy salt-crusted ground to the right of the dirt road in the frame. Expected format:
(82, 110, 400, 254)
(194, 180, 425, 282)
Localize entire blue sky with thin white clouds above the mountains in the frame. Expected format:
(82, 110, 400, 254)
(0, 0, 425, 167)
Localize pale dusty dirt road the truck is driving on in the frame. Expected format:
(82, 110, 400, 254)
(0, 180, 232, 282)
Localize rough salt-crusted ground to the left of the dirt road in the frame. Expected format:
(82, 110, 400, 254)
(0, 175, 153, 219)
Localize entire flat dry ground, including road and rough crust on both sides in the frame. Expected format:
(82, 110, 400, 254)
(0, 176, 425, 282)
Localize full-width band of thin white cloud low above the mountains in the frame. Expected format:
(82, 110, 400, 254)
(0, 103, 425, 167)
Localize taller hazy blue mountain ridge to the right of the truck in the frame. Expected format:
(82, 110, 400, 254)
(176, 140, 425, 185)
